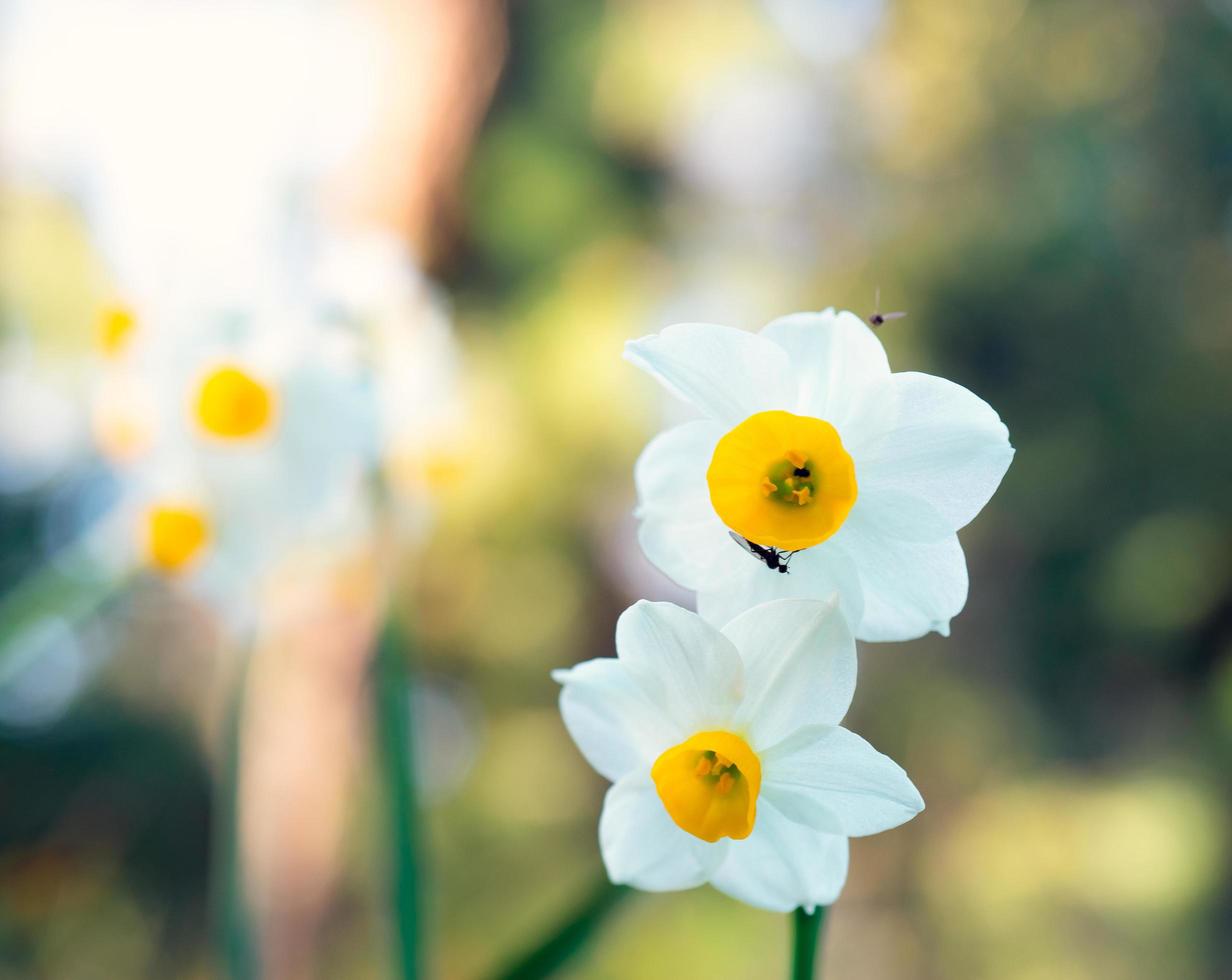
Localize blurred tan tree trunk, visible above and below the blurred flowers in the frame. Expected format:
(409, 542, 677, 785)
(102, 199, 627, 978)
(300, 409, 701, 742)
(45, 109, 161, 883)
(240, 0, 505, 980)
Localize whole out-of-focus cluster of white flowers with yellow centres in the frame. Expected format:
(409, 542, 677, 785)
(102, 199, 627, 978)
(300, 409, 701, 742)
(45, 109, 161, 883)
(70, 234, 460, 618)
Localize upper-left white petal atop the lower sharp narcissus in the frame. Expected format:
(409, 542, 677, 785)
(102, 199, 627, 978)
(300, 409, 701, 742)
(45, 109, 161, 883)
(616, 599, 744, 736)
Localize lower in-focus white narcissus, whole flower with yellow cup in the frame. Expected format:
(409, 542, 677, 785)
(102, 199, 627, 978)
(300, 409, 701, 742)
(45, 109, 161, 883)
(553, 599, 924, 911)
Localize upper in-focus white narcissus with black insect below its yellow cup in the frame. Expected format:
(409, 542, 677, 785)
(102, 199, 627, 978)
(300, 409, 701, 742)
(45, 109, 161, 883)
(626, 309, 1014, 640)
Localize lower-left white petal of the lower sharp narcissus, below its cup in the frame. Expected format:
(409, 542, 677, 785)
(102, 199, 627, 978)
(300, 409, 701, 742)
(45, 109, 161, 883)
(599, 770, 727, 891)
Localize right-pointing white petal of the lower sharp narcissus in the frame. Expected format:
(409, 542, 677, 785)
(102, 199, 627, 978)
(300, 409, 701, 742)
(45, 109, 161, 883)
(758, 725, 924, 837)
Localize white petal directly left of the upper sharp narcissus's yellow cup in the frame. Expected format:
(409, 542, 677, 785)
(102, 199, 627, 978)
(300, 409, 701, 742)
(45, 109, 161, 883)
(633, 419, 732, 589)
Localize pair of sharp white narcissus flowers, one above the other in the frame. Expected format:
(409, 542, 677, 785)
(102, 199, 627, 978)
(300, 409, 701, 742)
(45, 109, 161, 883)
(553, 309, 1014, 911)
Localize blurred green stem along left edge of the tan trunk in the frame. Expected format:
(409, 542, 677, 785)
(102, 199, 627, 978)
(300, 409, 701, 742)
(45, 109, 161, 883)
(212, 652, 261, 980)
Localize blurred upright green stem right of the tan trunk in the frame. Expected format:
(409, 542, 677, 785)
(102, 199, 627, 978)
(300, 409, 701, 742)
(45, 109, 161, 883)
(373, 623, 423, 980)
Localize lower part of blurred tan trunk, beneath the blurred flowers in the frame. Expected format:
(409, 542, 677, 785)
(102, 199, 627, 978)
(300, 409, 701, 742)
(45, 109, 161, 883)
(240, 558, 382, 978)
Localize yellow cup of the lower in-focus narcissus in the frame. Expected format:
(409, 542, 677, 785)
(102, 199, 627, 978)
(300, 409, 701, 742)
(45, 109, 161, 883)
(650, 731, 761, 843)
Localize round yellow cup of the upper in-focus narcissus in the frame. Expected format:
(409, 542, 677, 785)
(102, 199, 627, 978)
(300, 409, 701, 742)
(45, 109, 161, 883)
(706, 412, 856, 551)
